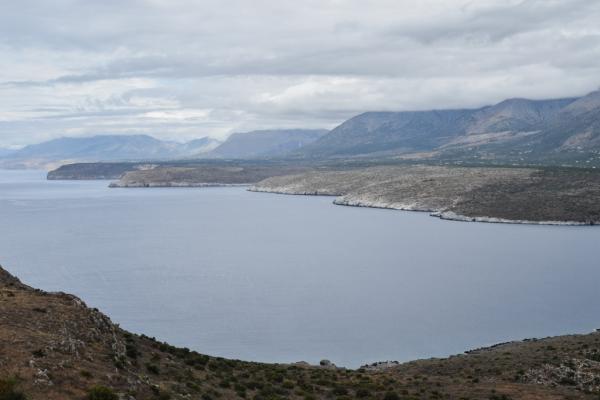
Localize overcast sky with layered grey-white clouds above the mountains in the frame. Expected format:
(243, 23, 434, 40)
(0, 0, 600, 147)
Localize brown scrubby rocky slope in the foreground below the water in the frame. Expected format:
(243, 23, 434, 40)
(0, 268, 600, 400)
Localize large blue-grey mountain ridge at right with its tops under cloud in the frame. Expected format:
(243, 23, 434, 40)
(295, 91, 600, 161)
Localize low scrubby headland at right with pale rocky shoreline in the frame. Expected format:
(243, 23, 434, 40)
(250, 165, 600, 225)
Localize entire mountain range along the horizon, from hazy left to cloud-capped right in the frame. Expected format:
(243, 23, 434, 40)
(0, 91, 600, 167)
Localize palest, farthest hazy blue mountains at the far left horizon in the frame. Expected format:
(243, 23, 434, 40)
(0, 135, 219, 168)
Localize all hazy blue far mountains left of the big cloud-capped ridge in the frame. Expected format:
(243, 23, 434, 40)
(0, 129, 327, 168)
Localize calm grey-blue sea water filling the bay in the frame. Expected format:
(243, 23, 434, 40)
(0, 171, 600, 367)
